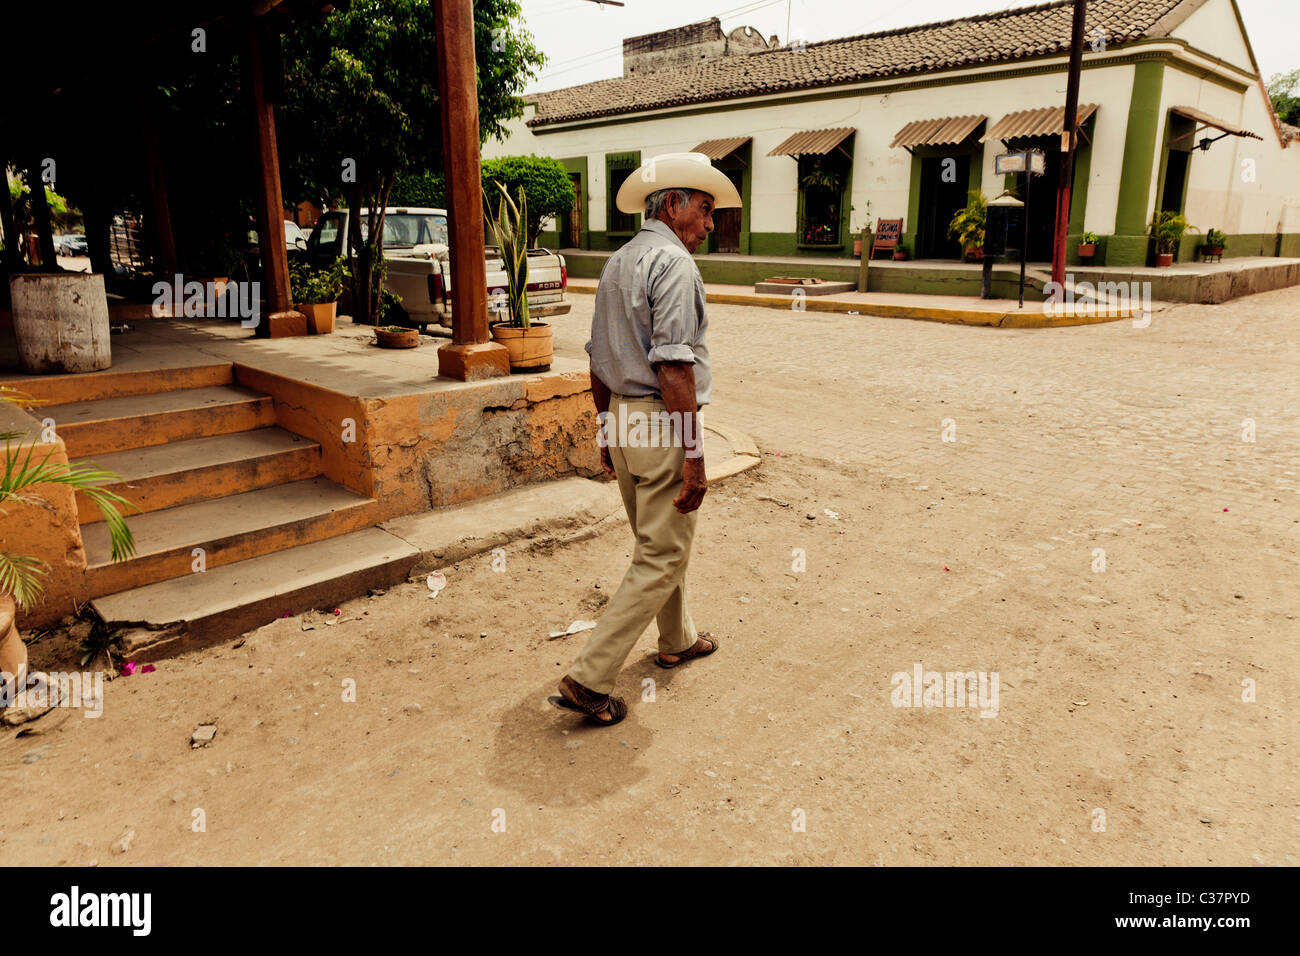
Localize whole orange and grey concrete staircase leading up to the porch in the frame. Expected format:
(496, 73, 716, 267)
(29, 363, 420, 659)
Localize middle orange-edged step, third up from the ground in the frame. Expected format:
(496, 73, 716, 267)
(74, 427, 321, 525)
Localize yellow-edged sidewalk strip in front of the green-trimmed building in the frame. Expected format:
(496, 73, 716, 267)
(568, 278, 1167, 329)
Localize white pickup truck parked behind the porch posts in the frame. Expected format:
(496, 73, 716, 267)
(307, 207, 571, 329)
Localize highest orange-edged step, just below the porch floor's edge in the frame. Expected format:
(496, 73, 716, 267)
(43, 385, 276, 458)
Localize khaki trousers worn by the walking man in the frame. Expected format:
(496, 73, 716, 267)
(569, 395, 698, 693)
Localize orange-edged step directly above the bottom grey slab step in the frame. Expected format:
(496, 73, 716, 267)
(82, 477, 378, 597)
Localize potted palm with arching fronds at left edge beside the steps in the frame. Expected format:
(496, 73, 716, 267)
(0, 385, 135, 701)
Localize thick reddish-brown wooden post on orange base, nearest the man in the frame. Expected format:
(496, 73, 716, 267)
(433, 0, 510, 381)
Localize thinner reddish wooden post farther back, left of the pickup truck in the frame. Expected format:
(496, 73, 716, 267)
(247, 20, 297, 337)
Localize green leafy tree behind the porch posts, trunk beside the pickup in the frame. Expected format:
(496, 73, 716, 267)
(282, 0, 545, 324)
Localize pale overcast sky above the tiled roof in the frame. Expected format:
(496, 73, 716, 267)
(521, 0, 1300, 92)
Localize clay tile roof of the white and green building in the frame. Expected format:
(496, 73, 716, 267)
(528, 0, 1195, 126)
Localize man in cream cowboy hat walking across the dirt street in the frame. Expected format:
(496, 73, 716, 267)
(550, 152, 741, 726)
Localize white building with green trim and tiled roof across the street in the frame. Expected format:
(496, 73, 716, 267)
(484, 0, 1300, 265)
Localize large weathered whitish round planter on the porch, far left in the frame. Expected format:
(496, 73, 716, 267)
(9, 272, 113, 373)
